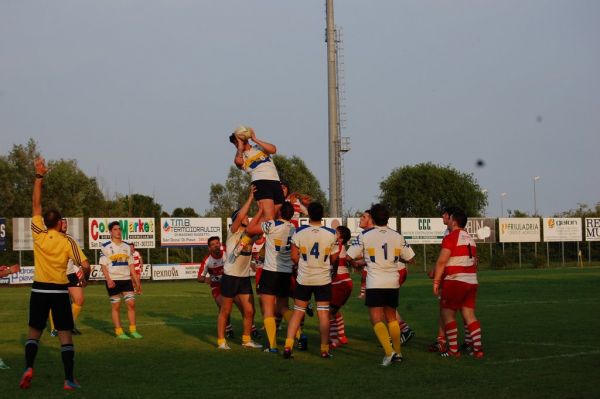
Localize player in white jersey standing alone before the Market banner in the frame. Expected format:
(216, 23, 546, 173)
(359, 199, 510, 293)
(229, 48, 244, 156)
(99, 221, 143, 339)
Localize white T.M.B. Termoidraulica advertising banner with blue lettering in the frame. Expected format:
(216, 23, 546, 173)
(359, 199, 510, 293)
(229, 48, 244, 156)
(160, 218, 222, 247)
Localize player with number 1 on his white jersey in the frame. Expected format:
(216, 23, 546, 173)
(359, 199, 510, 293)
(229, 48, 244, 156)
(348, 204, 415, 366)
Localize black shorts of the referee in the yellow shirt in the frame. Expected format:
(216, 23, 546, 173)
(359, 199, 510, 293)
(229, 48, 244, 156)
(29, 281, 74, 331)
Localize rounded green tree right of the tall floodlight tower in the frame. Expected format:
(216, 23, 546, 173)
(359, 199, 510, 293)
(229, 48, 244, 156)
(379, 162, 487, 217)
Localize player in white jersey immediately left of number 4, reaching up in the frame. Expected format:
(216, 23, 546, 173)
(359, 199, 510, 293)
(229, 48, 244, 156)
(247, 202, 295, 353)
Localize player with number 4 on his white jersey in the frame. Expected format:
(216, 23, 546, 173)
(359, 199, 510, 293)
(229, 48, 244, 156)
(283, 202, 338, 359)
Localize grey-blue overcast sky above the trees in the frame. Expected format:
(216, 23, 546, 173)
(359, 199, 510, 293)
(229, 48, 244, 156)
(0, 0, 600, 216)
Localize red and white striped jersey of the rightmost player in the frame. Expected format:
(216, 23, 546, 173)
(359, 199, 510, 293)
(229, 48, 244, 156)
(442, 229, 477, 284)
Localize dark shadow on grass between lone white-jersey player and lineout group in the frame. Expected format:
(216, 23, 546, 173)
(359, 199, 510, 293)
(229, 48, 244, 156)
(146, 311, 217, 345)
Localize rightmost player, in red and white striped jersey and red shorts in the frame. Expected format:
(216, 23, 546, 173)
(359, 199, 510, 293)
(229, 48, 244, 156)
(433, 208, 483, 359)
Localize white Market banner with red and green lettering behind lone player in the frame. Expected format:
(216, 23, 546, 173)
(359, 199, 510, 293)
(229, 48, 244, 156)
(88, 218, 156, 249)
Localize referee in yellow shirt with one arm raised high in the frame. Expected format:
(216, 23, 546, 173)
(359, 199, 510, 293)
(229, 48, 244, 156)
(19, 157, 90, 390)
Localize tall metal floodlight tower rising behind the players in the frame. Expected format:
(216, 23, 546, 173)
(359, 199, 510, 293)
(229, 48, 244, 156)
(325, 0, 343, 217)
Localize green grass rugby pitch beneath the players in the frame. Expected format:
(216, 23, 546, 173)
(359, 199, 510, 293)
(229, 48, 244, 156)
(0, 268, 600, 399)
